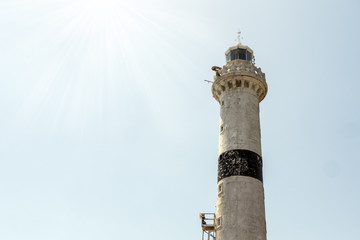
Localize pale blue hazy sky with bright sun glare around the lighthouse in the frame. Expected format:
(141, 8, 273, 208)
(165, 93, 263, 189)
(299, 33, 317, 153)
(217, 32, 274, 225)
(0, 0, 360, 240)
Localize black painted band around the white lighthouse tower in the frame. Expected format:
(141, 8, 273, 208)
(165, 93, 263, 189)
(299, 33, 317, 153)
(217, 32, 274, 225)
(218, 149, 263, 182)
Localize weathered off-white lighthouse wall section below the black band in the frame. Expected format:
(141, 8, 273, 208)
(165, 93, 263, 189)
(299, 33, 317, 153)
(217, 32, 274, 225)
(216, 176, 266, 240)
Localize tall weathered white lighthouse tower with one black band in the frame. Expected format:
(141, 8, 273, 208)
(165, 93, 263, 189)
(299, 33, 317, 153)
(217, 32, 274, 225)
(212, 38, 267, 240)
